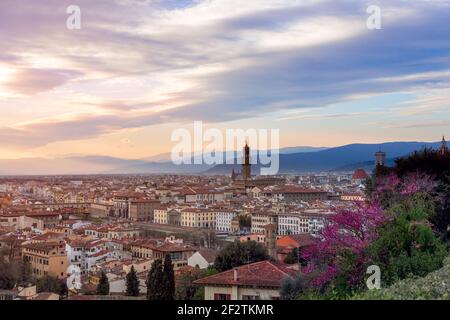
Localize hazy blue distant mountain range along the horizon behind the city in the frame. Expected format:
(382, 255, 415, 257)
(0, 142, 440, 175)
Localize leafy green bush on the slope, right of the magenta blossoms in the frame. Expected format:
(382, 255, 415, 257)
(369, 194, 448, 285)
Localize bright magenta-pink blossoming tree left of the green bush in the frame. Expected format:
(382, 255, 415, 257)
(302, 203, 387, 292)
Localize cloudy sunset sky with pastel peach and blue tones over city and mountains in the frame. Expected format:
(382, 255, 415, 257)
(0, 0, 450, 158)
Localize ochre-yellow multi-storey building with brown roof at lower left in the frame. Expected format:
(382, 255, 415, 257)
(22, 241, 67, 278)
